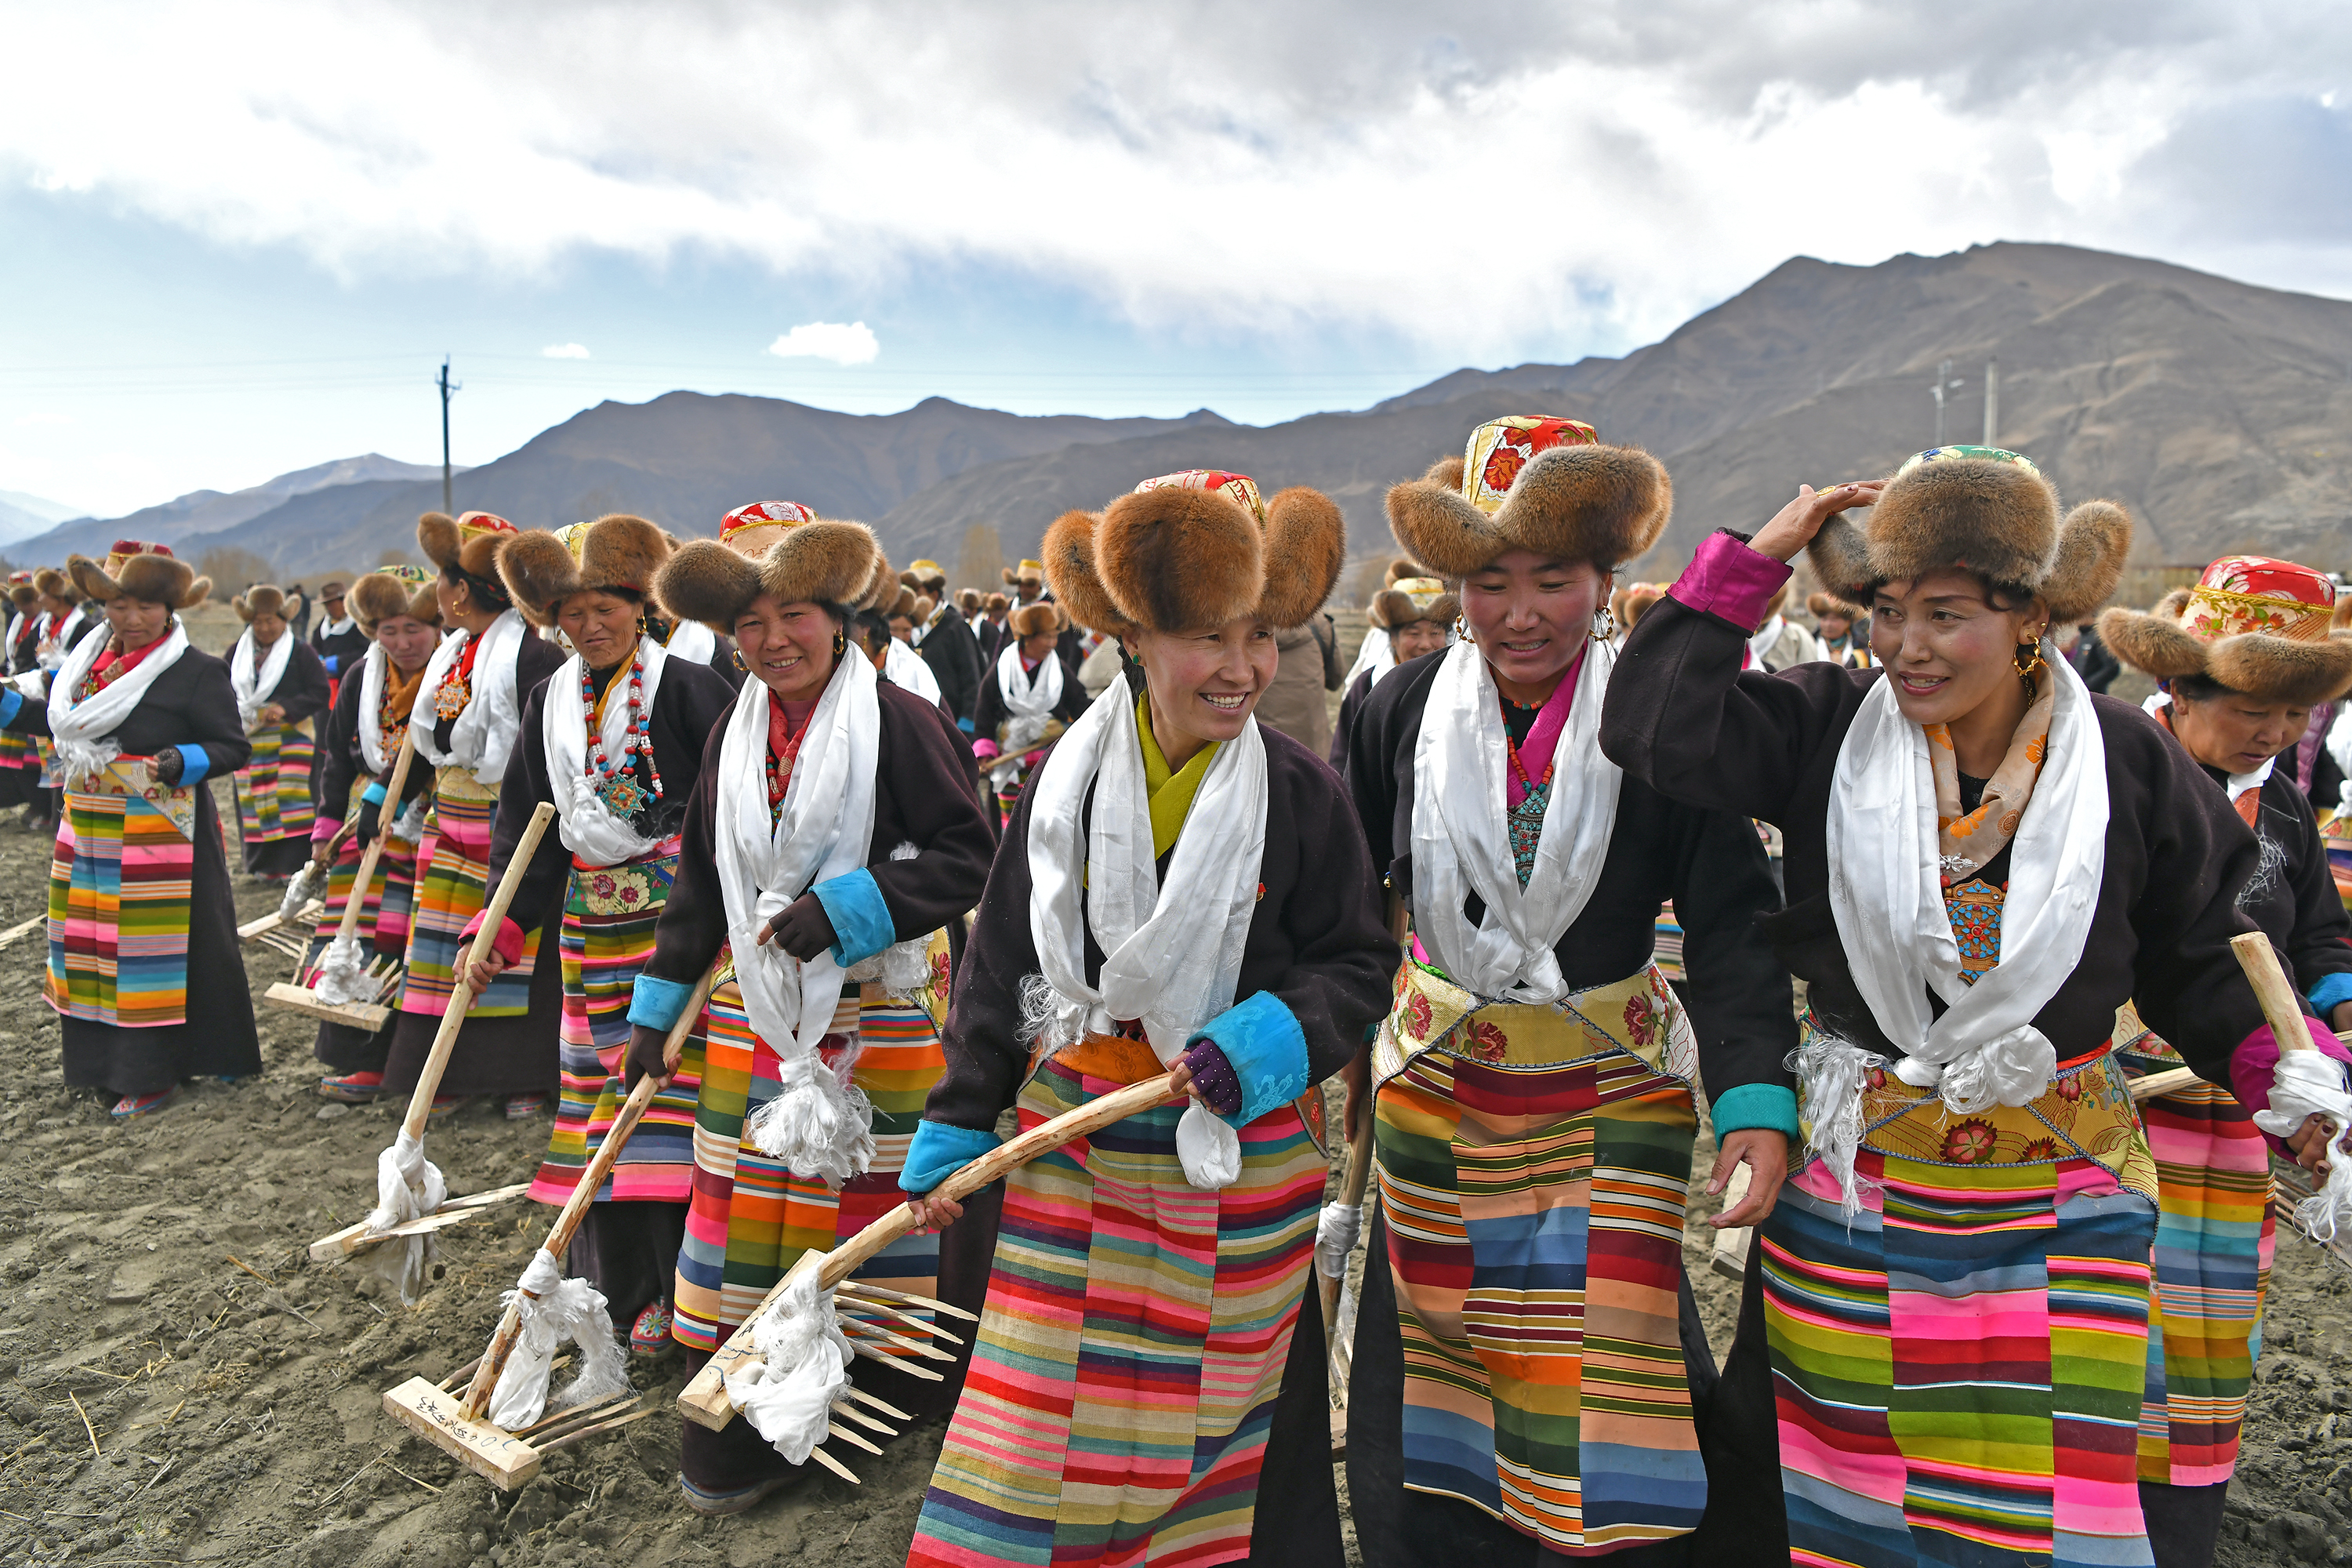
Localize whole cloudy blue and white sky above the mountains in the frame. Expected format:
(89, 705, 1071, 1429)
(0, 0, 2352, 513)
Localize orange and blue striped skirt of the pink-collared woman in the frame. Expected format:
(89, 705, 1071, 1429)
(1374, 964, 1708, 1556)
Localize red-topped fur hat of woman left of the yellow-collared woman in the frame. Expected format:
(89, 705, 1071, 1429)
(654, 501, 894, 633)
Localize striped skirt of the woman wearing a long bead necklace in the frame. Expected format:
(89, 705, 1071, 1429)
(532, 839, 703, 1203)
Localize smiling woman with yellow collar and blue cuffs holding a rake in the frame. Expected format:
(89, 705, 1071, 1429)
(901, 473, 1397, 1568)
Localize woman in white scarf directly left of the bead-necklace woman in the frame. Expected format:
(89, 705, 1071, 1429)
(383, 513, 564, 1121)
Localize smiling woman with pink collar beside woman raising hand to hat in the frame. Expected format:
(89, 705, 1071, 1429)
(1348, 419, 1797, 1568)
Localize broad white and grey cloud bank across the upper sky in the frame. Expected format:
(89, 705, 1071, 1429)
(0, 0, 2352, 360)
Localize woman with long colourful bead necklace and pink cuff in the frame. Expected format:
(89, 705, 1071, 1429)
(466, 513, 734, 1354)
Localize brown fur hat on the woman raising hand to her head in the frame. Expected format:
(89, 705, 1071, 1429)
(1806, 447, 2131, 626)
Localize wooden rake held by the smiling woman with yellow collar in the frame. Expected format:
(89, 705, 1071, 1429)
(677, 1072, 1195, 1481)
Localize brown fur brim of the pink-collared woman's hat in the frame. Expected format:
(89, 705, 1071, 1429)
(1388, 432, 1675, 579)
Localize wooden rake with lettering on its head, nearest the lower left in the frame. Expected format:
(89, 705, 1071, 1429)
(383, 966, 717, 1490)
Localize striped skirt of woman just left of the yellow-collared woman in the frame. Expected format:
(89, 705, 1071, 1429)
(670, 980, 946, 1352)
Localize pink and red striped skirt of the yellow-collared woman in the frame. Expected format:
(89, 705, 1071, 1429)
(906, 1044, 1327, 1568)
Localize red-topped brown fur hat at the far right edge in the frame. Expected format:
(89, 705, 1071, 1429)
(2098, 555, 2352, 706)
